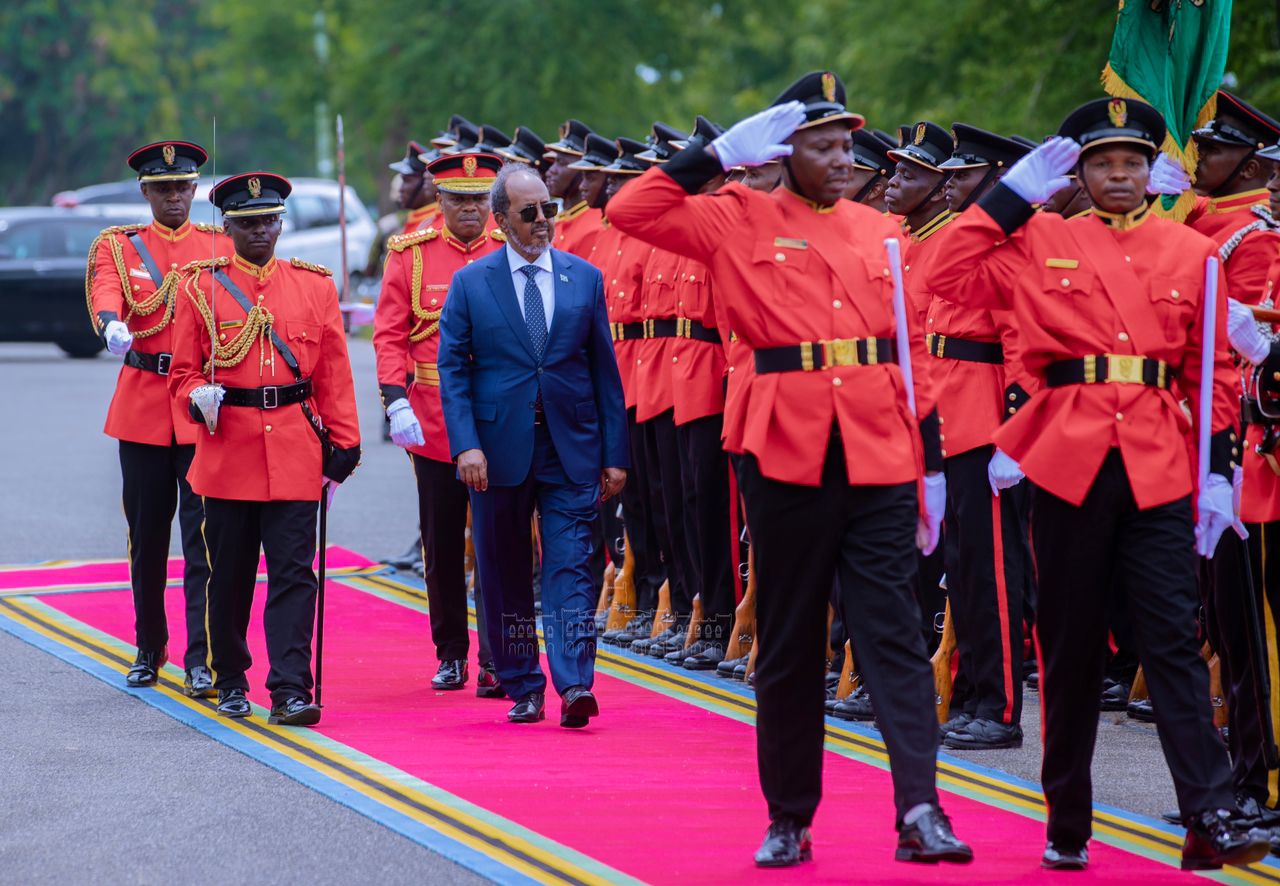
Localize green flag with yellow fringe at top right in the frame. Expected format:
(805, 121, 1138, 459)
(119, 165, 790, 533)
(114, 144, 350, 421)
(1102, 0, 1231, 218)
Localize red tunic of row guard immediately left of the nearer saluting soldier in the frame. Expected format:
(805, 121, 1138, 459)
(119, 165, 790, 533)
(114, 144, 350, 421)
(671, 257, 727, 425)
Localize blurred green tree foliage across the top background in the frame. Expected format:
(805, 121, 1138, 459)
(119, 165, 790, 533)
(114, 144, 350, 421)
(0, 0, 1280, 204)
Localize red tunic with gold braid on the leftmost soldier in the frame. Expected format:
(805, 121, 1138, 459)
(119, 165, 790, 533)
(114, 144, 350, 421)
(86, 222, 232, 446)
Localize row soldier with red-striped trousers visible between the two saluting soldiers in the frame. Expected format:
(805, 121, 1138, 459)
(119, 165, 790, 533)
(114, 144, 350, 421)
(924, 123, 1036, 750)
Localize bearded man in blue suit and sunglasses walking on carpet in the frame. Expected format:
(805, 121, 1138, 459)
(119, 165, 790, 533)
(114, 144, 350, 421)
(439, 164, 630, 727)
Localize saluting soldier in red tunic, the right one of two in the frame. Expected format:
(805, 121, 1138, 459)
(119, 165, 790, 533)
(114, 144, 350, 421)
(929, 99, 1268, 869)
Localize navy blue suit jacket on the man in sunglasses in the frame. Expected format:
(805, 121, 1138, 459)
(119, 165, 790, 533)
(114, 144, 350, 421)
(438, 248, 631, 487)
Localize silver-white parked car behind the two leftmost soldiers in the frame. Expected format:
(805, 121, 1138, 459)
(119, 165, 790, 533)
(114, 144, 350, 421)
(54, 177, 378, 292)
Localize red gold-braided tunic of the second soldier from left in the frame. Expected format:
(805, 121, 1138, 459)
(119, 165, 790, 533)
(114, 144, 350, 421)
(169, 255, 363, 502)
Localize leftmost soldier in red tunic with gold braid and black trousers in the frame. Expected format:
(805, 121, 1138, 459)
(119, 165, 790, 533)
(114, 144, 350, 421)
(84, 141, 230, 698)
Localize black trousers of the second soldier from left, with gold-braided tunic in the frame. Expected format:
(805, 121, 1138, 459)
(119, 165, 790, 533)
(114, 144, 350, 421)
(205, 498, 319, 704)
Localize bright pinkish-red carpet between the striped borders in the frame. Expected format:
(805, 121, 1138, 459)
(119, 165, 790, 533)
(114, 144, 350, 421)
(27, 549, 1249, 883)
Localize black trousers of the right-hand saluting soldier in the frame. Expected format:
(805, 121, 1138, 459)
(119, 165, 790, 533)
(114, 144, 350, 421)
(1032, 449, 1233, 848)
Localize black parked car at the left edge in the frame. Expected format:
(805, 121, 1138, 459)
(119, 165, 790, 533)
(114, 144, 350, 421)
(0, 206, 144, 357)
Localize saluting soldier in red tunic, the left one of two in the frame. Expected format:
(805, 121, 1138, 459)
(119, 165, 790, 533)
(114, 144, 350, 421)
(609, 72, 973, 867)
